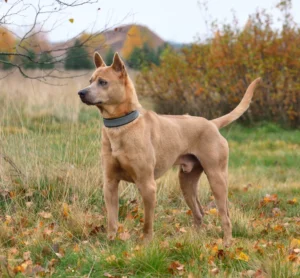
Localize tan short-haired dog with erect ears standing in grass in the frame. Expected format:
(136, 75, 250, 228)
(78, 53, 260, 244)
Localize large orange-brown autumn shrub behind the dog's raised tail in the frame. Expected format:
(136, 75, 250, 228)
(137, 1, 300, 127)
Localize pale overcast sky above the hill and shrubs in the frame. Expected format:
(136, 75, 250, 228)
(0, 0, 300, 43)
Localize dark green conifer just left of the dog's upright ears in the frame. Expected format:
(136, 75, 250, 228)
(65, 40, 94, 70)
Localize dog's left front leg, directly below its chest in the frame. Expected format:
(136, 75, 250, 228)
(103, 180, 119, 240)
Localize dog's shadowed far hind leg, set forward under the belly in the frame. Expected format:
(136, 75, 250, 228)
(179, 162, 204, 226)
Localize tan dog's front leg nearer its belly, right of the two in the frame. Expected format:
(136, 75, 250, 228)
(136, 179, 156, 242)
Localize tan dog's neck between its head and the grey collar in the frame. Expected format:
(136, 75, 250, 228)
(98, 77, 142, 119)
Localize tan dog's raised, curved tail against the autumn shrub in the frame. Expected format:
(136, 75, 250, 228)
(211, 78, 261, 129)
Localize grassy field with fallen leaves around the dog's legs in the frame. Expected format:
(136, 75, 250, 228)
(0, 71, 300, 277)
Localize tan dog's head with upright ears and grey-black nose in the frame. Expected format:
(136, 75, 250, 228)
(78, 52, 128, 108)
